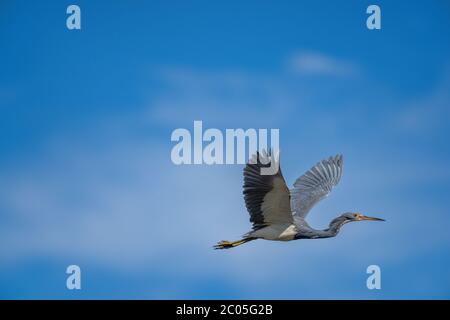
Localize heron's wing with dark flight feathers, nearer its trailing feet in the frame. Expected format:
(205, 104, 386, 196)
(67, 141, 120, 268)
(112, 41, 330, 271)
(244, 151, 293, 229)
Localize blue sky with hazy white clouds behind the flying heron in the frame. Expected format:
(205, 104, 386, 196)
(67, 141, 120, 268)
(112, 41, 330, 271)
(0, 1, 450, 299)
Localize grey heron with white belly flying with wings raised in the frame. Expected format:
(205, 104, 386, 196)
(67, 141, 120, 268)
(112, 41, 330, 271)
(214, 150, 385, 249)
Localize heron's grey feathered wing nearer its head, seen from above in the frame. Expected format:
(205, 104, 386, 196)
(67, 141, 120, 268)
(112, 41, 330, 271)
(291, 155, 343, 219)
